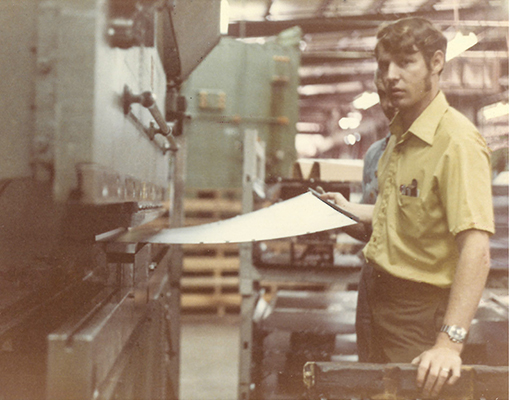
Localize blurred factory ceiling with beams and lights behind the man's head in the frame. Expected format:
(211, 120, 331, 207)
(228, 0, 509, 156)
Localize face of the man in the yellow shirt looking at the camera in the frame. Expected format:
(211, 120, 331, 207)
(377, 50, 432, 112)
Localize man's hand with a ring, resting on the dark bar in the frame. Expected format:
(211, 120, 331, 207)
(412, 347, 462, 397)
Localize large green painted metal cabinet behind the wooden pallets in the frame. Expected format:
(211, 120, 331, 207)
(182, 28, 301, 188)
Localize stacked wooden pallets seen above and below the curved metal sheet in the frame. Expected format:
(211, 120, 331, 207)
(181, 189, 242, 315)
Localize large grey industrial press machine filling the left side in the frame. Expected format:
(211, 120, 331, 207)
(0, 0, 220, 400)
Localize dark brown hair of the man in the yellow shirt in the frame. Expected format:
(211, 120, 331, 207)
(375, 17, 447, 66)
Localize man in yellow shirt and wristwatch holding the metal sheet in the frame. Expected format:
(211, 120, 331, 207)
(323, 18, 494, 396)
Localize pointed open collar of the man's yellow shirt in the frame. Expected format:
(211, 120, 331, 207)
(390, 91, 449, 145)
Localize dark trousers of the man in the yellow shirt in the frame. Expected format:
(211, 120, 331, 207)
(358, 267, 450, 363)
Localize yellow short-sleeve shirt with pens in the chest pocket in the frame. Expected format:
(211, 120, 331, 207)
(364, 92, 494, 287)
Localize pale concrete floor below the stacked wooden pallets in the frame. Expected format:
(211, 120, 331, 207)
(180, 315, 240, 400)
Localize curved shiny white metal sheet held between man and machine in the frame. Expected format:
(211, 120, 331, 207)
(110, 192, 356, 244)
